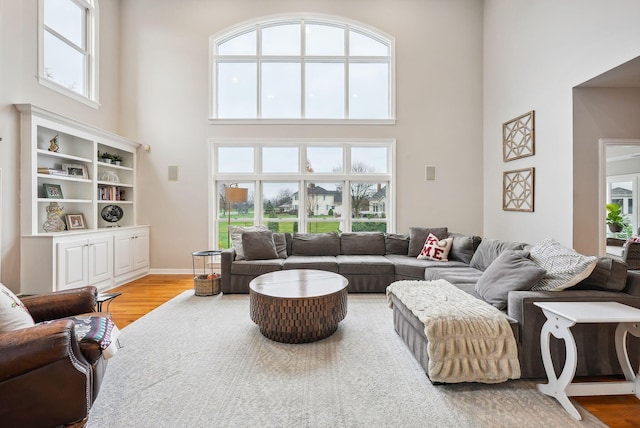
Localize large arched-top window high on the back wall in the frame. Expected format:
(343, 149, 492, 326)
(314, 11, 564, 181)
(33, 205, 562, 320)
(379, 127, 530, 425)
(211, 17, 395, 121)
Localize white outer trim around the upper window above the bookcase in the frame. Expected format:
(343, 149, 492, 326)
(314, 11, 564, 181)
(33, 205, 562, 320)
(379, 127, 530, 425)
(36, 0, 100, 109)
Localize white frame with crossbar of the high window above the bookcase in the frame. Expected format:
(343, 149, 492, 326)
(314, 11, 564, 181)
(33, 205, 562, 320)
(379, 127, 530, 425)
(37, 0, 100, 109)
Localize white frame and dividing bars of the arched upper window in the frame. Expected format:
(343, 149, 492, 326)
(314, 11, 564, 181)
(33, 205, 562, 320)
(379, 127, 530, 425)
(209, 14, 396, 125)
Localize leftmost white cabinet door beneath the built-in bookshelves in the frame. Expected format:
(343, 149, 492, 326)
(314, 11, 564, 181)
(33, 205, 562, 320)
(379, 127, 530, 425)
(57, 239, 89, 290)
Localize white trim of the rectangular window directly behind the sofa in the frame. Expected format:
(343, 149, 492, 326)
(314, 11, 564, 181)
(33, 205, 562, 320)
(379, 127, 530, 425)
(208, 138, 396, 248)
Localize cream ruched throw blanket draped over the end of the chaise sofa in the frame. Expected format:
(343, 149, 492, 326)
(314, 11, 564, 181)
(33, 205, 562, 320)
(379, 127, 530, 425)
(387, 279, 520, 383)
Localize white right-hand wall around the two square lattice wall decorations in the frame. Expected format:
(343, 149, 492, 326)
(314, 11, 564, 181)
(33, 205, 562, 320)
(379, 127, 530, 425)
(483, 0, 640, 246)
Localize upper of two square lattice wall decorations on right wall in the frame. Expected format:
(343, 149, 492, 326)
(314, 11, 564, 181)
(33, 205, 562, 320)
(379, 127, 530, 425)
(502, 110, 535, 162)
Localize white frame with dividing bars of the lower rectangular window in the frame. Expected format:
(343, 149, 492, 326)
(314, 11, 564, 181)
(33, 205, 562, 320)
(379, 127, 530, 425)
(208, 138, 396, 248)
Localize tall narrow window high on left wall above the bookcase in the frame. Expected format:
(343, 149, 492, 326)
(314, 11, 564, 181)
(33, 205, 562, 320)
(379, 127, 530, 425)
(38, 0, 98, 105)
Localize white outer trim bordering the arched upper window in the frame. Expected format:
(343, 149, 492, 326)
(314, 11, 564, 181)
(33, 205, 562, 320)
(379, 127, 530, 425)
(209, 13, 396, 125)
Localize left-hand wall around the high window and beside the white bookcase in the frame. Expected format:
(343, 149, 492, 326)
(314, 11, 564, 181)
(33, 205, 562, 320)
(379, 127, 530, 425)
(0, 0, 120, 291)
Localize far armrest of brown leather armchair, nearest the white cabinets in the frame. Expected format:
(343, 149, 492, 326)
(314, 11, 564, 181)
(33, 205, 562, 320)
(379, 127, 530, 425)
(20, 286, 98, 322)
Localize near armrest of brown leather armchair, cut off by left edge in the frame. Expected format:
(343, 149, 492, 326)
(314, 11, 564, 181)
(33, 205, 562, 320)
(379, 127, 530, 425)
(0, 320, 90, 382)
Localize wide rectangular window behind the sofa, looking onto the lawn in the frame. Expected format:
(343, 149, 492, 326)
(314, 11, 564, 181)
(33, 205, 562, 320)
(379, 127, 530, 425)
(211, 141, 395, 248)
